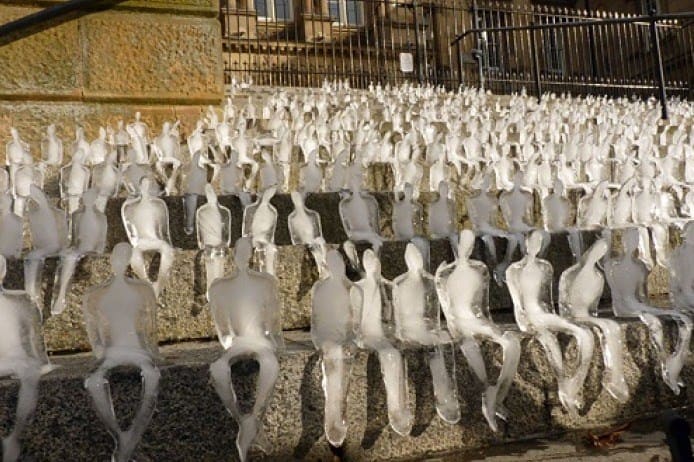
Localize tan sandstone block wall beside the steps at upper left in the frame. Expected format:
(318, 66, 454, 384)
(0, 0, 223, 153)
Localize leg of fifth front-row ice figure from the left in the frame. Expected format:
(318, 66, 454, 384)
(373, 341, 413, 436)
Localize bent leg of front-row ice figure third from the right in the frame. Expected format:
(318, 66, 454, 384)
(581, 318, 629, 403)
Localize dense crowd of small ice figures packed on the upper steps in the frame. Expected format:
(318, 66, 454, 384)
(6, 85, 694, 205)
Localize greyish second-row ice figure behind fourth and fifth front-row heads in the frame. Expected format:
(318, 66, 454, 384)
(339, 180, 383, 255)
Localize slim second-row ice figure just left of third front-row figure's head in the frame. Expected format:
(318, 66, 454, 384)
(195, 184, 231, 290)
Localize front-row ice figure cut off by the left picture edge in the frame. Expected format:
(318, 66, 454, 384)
(0, 256, 54, 462)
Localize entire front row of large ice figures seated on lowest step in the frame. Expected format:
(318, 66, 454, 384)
(0, 220, 694, 462)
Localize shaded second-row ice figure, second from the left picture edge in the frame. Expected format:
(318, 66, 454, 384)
(24, 186, 68, 304)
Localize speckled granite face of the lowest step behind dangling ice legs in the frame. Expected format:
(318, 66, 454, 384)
(6, 322, 694, 462)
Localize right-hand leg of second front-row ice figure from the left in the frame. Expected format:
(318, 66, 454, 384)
(116, 363, 161, 462)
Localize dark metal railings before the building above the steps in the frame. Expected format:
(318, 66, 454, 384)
(221, 0, 694, 96)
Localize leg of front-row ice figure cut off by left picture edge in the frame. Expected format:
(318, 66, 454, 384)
(2, 367, 41, 462)
